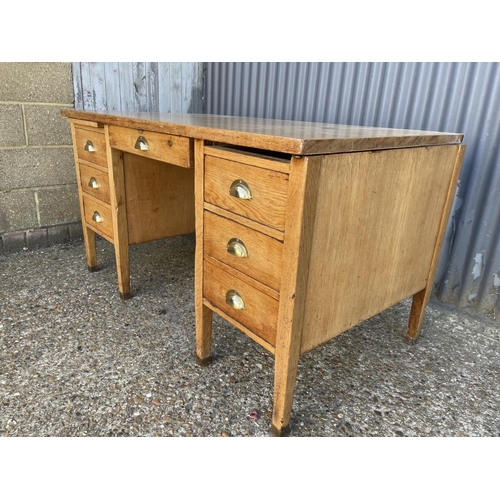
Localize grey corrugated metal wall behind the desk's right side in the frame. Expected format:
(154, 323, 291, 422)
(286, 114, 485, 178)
(206, 62, 500, 317)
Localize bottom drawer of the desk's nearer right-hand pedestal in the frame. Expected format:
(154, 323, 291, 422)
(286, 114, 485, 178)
(203, 259, 278, 346)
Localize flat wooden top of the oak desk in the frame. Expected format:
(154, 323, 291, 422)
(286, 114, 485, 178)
(61, 108, 463, 155)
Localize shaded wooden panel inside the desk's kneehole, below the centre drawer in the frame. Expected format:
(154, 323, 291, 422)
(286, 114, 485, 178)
(123, 153, 195, 245)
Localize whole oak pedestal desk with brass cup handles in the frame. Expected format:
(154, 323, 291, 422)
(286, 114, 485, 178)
(61, 109, 465, 435)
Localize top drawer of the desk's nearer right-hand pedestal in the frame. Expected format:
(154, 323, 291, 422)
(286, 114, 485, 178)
(205, 155, 288, 231)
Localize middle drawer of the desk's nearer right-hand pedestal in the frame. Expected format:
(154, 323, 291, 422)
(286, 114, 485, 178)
(203, 211, 283, 290)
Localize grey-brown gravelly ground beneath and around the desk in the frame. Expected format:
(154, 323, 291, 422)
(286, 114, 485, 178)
(0, 235, 500, 437)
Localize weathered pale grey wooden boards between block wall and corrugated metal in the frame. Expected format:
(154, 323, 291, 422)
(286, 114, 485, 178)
(73, 62, 205, 113)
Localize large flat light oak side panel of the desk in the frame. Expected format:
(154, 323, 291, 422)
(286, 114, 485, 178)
(301, 145, 459, 352)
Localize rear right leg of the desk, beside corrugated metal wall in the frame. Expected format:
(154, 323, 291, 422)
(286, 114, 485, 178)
(406, 146, 465, 345)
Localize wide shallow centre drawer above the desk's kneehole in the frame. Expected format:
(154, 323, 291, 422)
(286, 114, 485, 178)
(109, 125, 193, 168)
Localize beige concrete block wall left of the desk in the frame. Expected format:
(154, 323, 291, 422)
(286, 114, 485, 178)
(0, 62, 82, 252)
